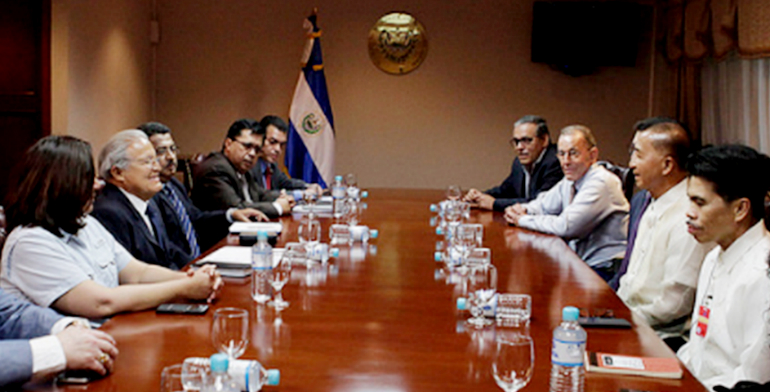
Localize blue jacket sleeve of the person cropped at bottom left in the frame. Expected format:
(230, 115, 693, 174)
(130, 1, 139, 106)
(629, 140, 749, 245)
(0, 289, 62, 387)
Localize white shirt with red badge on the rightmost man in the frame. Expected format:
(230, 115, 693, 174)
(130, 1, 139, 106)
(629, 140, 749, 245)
(677, 221, 770, 389)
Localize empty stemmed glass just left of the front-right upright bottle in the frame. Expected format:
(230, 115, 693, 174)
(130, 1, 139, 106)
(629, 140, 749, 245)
(492, 334, 535, 392)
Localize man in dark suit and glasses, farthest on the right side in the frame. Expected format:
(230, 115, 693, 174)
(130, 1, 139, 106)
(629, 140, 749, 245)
(463, 116, 564, 211)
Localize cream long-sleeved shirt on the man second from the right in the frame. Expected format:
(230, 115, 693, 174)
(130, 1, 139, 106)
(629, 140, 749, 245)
(618, 180, 714, 338)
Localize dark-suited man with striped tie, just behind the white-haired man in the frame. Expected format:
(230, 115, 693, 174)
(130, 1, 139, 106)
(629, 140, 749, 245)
(138, 122, 267, 254)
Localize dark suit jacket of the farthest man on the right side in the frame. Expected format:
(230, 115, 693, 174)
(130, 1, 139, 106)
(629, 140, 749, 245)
(485, 144, 564, 211)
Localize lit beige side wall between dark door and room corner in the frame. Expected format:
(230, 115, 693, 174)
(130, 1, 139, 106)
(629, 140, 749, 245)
(51, 0, 152, 155)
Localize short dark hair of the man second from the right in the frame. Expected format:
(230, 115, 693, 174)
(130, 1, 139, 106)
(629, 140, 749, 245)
(634, 117, 692, 169)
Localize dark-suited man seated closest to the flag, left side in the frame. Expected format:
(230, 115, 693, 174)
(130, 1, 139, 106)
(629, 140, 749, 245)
(251, 115, 323, 196)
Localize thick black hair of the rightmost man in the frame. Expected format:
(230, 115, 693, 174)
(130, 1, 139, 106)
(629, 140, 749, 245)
(687, 144, 770, 220)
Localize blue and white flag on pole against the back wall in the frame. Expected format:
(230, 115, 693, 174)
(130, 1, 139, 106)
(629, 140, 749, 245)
(285, 13, 334, 188)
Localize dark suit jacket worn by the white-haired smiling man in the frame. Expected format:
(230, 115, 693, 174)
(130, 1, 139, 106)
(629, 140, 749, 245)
(91, 183, 191, 269)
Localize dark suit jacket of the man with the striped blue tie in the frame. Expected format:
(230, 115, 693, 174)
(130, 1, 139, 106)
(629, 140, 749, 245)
(153, 177, 230, 251)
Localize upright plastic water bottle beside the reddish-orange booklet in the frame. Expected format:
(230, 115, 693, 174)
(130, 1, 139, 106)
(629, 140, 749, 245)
(550, 306, 587, 392)
